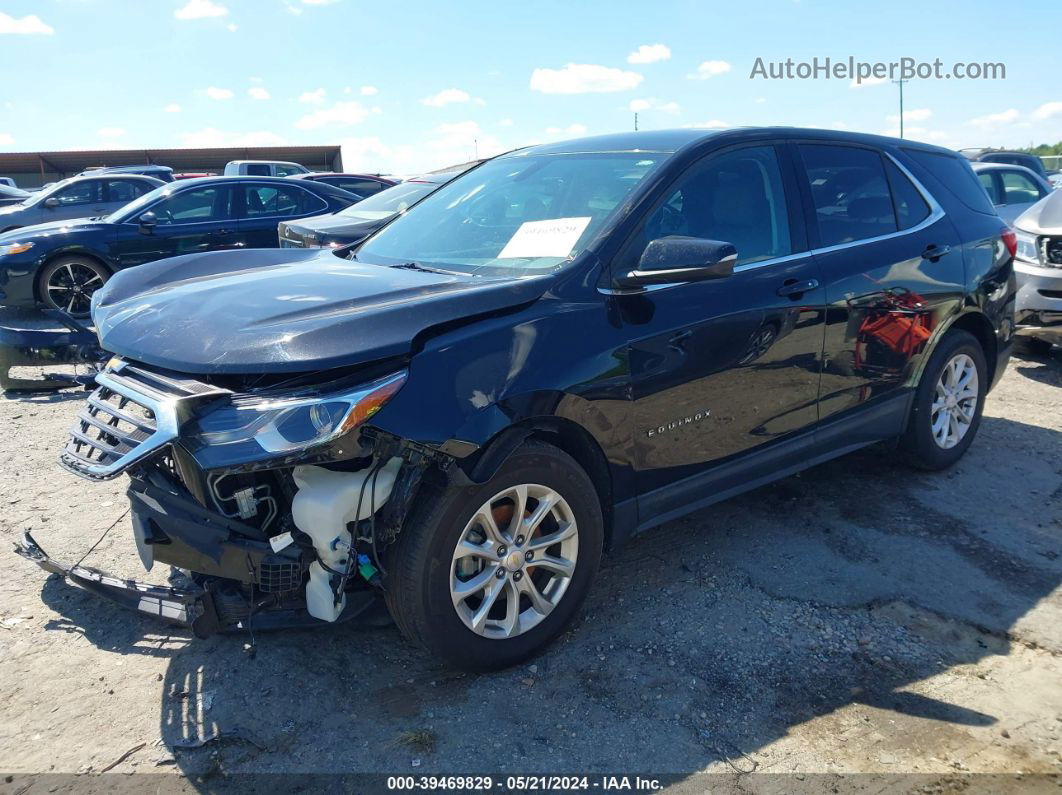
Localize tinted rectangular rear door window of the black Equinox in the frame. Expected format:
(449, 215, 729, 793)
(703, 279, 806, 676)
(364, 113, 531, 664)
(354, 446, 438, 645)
(800, 143, 896, 247)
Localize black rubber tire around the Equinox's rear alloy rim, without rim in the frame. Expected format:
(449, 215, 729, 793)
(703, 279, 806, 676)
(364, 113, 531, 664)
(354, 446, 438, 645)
(901, 329, 989, 470)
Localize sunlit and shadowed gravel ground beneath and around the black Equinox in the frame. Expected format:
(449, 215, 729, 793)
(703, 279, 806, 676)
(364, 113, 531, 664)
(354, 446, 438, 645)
(0, 316, 1062, 792)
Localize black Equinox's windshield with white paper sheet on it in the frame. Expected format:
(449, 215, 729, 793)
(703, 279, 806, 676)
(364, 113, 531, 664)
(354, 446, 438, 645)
(356, 152, 667, 276)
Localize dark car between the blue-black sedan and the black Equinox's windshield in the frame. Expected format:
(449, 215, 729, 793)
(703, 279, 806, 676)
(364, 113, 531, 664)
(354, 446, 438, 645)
(277, 169, 464, 248)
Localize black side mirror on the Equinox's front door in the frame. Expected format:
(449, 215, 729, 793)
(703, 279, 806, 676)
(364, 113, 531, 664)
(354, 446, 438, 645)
(613, 236, 737, 290)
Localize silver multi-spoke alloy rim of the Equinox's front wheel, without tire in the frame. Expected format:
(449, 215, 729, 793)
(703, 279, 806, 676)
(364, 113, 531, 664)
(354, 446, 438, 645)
(450, 484, 579, 639)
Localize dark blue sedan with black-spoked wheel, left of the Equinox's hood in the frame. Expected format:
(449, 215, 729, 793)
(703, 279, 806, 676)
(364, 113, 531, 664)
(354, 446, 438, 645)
(0, 177, 356, 317)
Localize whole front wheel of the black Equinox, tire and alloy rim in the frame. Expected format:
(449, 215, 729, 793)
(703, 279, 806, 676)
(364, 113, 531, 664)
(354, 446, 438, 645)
(387, 442, 603, 671)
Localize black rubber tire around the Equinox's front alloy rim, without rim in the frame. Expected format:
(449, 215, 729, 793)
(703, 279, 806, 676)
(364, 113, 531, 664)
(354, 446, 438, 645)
(386, 440, 604, 671)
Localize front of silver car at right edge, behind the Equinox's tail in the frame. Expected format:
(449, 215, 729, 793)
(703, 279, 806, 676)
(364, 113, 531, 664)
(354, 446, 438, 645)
(1014, 190, 1062, 353)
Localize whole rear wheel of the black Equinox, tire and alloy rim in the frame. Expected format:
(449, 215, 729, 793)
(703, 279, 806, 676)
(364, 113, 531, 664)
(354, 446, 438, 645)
(902, 329, 989, 469)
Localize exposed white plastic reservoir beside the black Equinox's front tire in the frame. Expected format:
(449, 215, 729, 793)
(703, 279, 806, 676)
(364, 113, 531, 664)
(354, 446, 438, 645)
(291, 456, 401, 621)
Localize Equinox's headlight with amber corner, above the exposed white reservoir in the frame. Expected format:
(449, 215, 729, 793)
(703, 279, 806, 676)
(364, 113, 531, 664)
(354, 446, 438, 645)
(189, 370, 407, 459)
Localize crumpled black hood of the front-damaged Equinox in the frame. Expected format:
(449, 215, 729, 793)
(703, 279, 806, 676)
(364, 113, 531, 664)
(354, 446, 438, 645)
(92, 248, 550, 374)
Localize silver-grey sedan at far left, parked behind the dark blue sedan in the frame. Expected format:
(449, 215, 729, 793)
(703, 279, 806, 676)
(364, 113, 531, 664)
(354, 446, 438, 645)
(0, 174, 166, 232)
